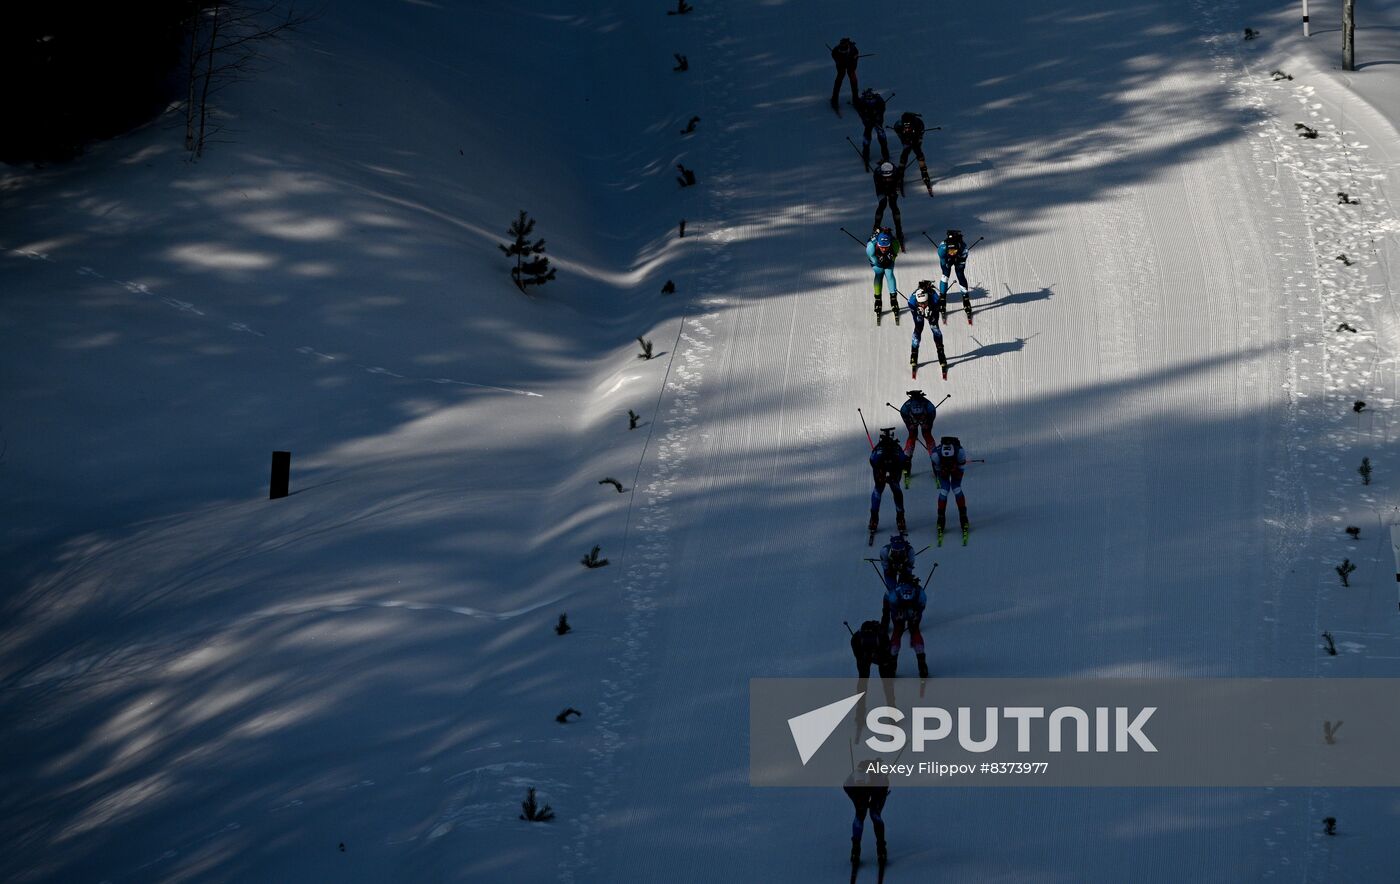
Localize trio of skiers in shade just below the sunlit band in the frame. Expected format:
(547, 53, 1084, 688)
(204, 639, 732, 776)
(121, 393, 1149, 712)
(867, 389, 972, 546)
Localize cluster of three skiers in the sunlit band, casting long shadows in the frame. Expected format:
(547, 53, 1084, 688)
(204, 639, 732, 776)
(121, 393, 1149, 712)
(865, 227, 980, 381)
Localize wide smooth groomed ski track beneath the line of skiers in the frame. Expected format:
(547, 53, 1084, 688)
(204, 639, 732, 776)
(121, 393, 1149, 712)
(584, 3, 1394, 881)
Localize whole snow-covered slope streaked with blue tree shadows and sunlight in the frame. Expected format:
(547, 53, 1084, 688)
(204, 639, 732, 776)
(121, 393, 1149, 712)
(0, 0, 1400, 881)
